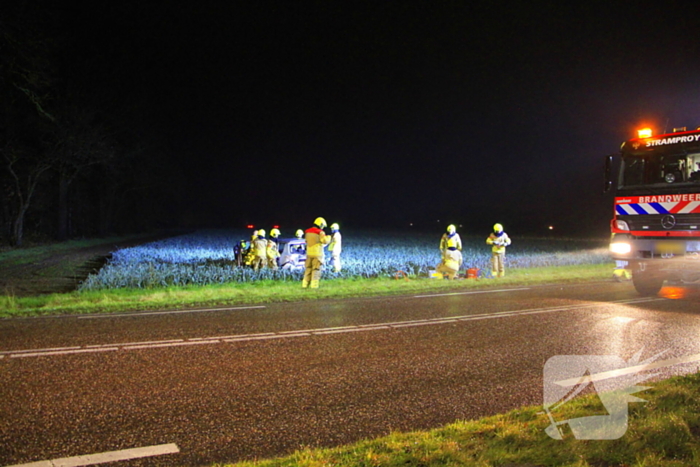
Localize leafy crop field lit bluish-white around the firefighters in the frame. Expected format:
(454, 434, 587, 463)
(80, 230, 610, 290)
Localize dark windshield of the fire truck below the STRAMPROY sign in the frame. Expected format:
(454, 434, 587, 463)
(619, 153, 700, 188)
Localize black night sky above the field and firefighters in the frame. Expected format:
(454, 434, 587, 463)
(57, 1, 700, 234)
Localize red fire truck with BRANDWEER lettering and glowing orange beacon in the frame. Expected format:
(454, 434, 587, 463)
(605, 128, 700, 295)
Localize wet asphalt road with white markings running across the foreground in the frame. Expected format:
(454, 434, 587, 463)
(0, 282, 700, 465)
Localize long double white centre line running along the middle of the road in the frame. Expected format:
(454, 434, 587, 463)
(0, 298, 664, 358)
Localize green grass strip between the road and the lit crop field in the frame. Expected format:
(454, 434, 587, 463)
(0, 264, 613, 317)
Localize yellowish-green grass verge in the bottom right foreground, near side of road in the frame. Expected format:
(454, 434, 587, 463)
(217, 374, 700, 467)
